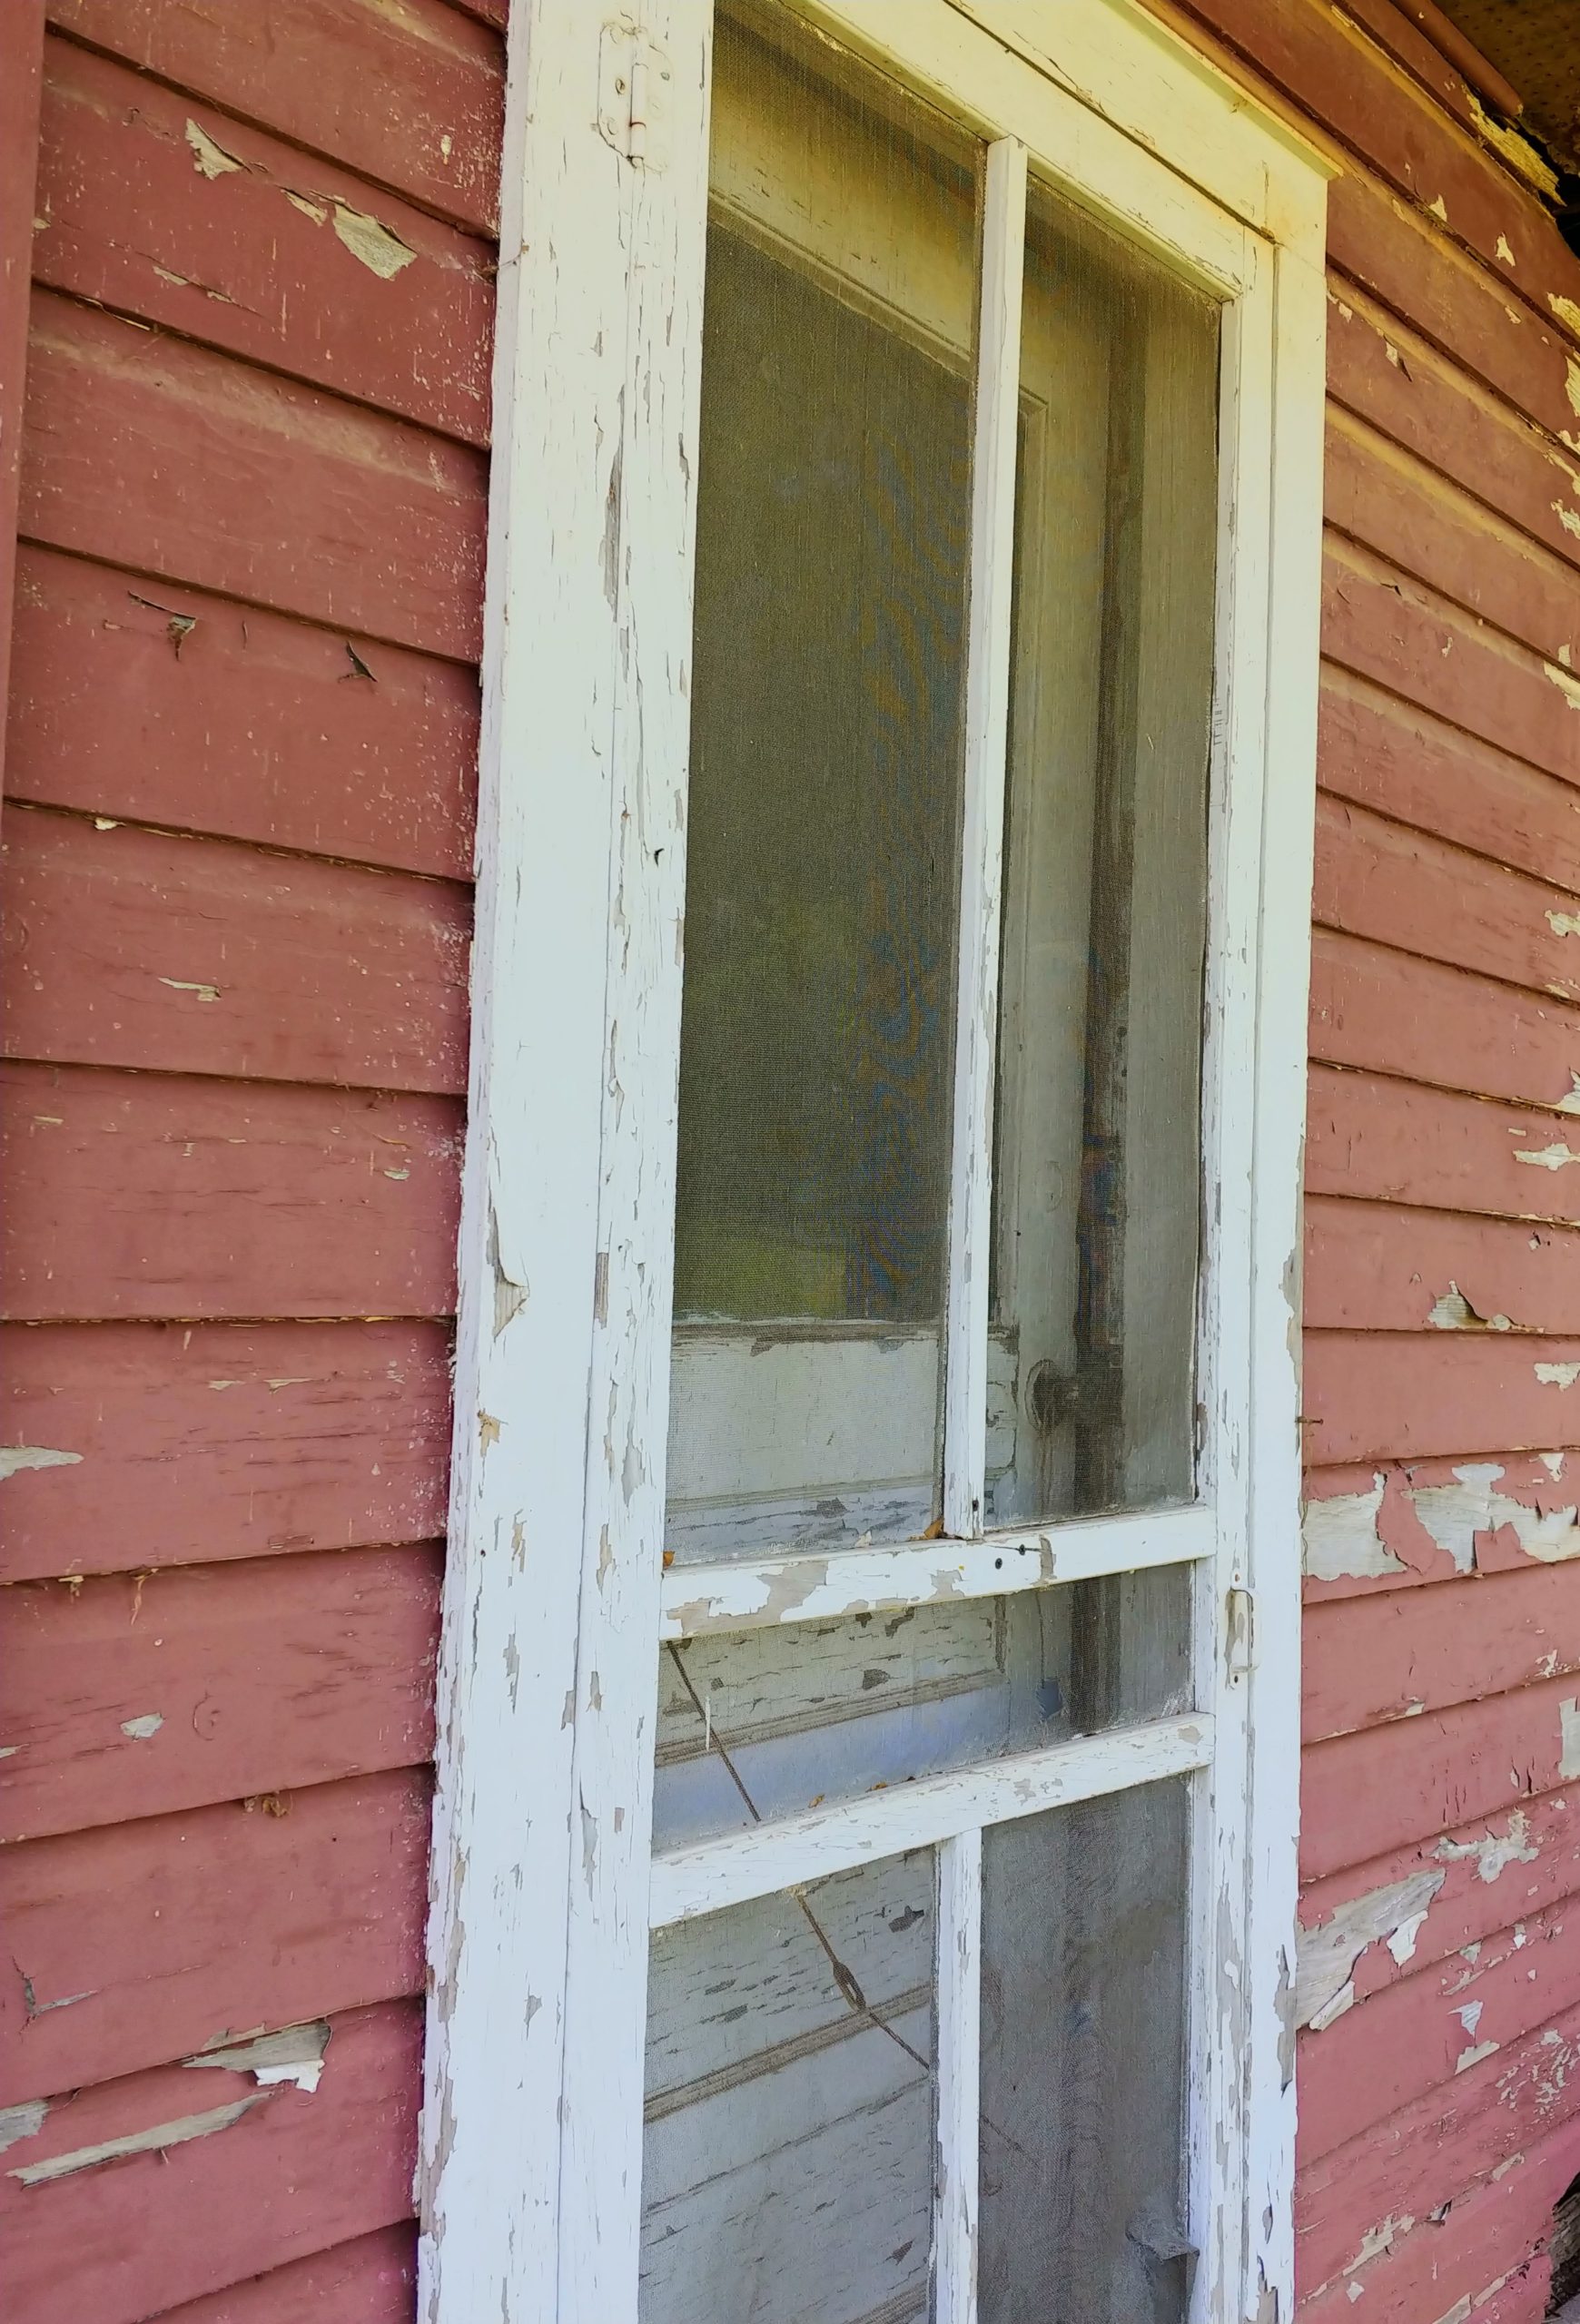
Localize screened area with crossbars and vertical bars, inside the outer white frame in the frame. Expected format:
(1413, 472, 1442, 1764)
(641, 9, 1220, 2324)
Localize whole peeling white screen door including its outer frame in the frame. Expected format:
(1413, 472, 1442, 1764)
(425, 0, 1322, 2324)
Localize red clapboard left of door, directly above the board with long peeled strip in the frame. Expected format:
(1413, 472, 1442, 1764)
(0, 1757, 428, 2105)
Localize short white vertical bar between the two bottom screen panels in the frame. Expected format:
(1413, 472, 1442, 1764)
(934, 1827, 983, 2324)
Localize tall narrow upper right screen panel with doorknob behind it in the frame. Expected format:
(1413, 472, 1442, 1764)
(988, 186, 1220, 1524)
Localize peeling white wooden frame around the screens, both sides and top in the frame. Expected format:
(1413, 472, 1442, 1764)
(419, 0, 1327, 2324)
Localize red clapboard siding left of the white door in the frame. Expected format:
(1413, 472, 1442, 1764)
(0, 0, 502, 2324)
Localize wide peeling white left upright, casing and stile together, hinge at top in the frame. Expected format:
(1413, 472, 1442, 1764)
(419, 0, 711, 2324)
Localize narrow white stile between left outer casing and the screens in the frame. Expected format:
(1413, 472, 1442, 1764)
(556, 18, 714, 2324)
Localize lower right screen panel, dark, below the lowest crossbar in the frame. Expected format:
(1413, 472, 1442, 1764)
(978, 1783, 1194, 2324)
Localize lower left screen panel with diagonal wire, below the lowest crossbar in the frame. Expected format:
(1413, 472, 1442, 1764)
(639, 1850, 936, 2324)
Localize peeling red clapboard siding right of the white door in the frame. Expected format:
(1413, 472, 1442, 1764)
(1142, 0, 1580, 2324)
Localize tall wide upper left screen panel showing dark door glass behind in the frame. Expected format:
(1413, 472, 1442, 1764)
(669, 21, 976, 1555)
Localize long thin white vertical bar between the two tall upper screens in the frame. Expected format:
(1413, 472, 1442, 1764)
(943, 137, 1027, 1541)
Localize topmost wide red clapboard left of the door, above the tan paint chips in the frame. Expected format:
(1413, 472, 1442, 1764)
(49, 0, 504, 232)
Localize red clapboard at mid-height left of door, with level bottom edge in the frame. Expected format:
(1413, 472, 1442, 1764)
(0, 1064, 460, 1323)
